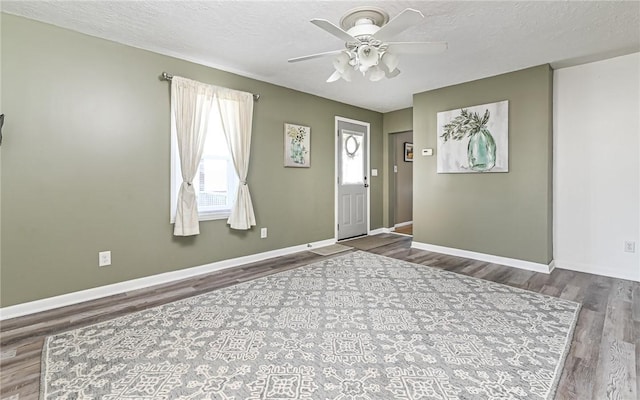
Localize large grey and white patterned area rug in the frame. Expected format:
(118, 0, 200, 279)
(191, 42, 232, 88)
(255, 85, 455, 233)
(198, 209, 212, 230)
(41, 252, 580, 400)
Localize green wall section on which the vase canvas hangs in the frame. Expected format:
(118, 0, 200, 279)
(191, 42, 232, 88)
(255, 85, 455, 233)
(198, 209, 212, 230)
(413, 65, 553, 264)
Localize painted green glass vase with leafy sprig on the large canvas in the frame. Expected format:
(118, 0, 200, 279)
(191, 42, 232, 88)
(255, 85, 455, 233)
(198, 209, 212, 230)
(441, 109, 496, 172)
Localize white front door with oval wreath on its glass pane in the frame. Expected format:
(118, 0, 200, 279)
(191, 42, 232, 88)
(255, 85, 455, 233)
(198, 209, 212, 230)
(336, 119, 369, 240)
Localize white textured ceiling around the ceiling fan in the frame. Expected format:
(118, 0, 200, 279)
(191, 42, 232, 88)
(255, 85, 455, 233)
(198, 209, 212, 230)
(0, 0, 640, 112)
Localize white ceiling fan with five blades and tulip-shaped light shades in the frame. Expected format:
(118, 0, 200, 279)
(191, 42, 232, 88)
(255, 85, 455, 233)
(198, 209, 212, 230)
(288, 7, 447, 82)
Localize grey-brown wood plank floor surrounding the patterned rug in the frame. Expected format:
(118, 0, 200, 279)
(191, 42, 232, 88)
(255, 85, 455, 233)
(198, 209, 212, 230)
(0, 234, 640, 400)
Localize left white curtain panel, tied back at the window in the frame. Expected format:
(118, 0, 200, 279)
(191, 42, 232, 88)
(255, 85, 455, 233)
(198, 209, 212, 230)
(171, 76, 215, 236)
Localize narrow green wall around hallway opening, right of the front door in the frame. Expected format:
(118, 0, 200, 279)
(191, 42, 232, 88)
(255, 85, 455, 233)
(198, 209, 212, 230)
(382, 107, 413, 228)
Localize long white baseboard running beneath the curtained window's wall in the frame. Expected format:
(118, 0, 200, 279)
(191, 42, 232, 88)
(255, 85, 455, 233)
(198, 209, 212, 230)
(0, 239, 336, 321)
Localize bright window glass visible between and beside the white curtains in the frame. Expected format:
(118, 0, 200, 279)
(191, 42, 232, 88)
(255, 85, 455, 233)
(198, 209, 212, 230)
(171, 108, 238, 223)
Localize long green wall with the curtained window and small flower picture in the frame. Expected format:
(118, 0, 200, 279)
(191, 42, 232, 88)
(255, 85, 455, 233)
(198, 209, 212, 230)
(0, 14, 383, 307)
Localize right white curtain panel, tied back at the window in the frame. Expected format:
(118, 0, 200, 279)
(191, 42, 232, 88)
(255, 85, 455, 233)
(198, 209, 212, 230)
(216, 88, 256, 230)
